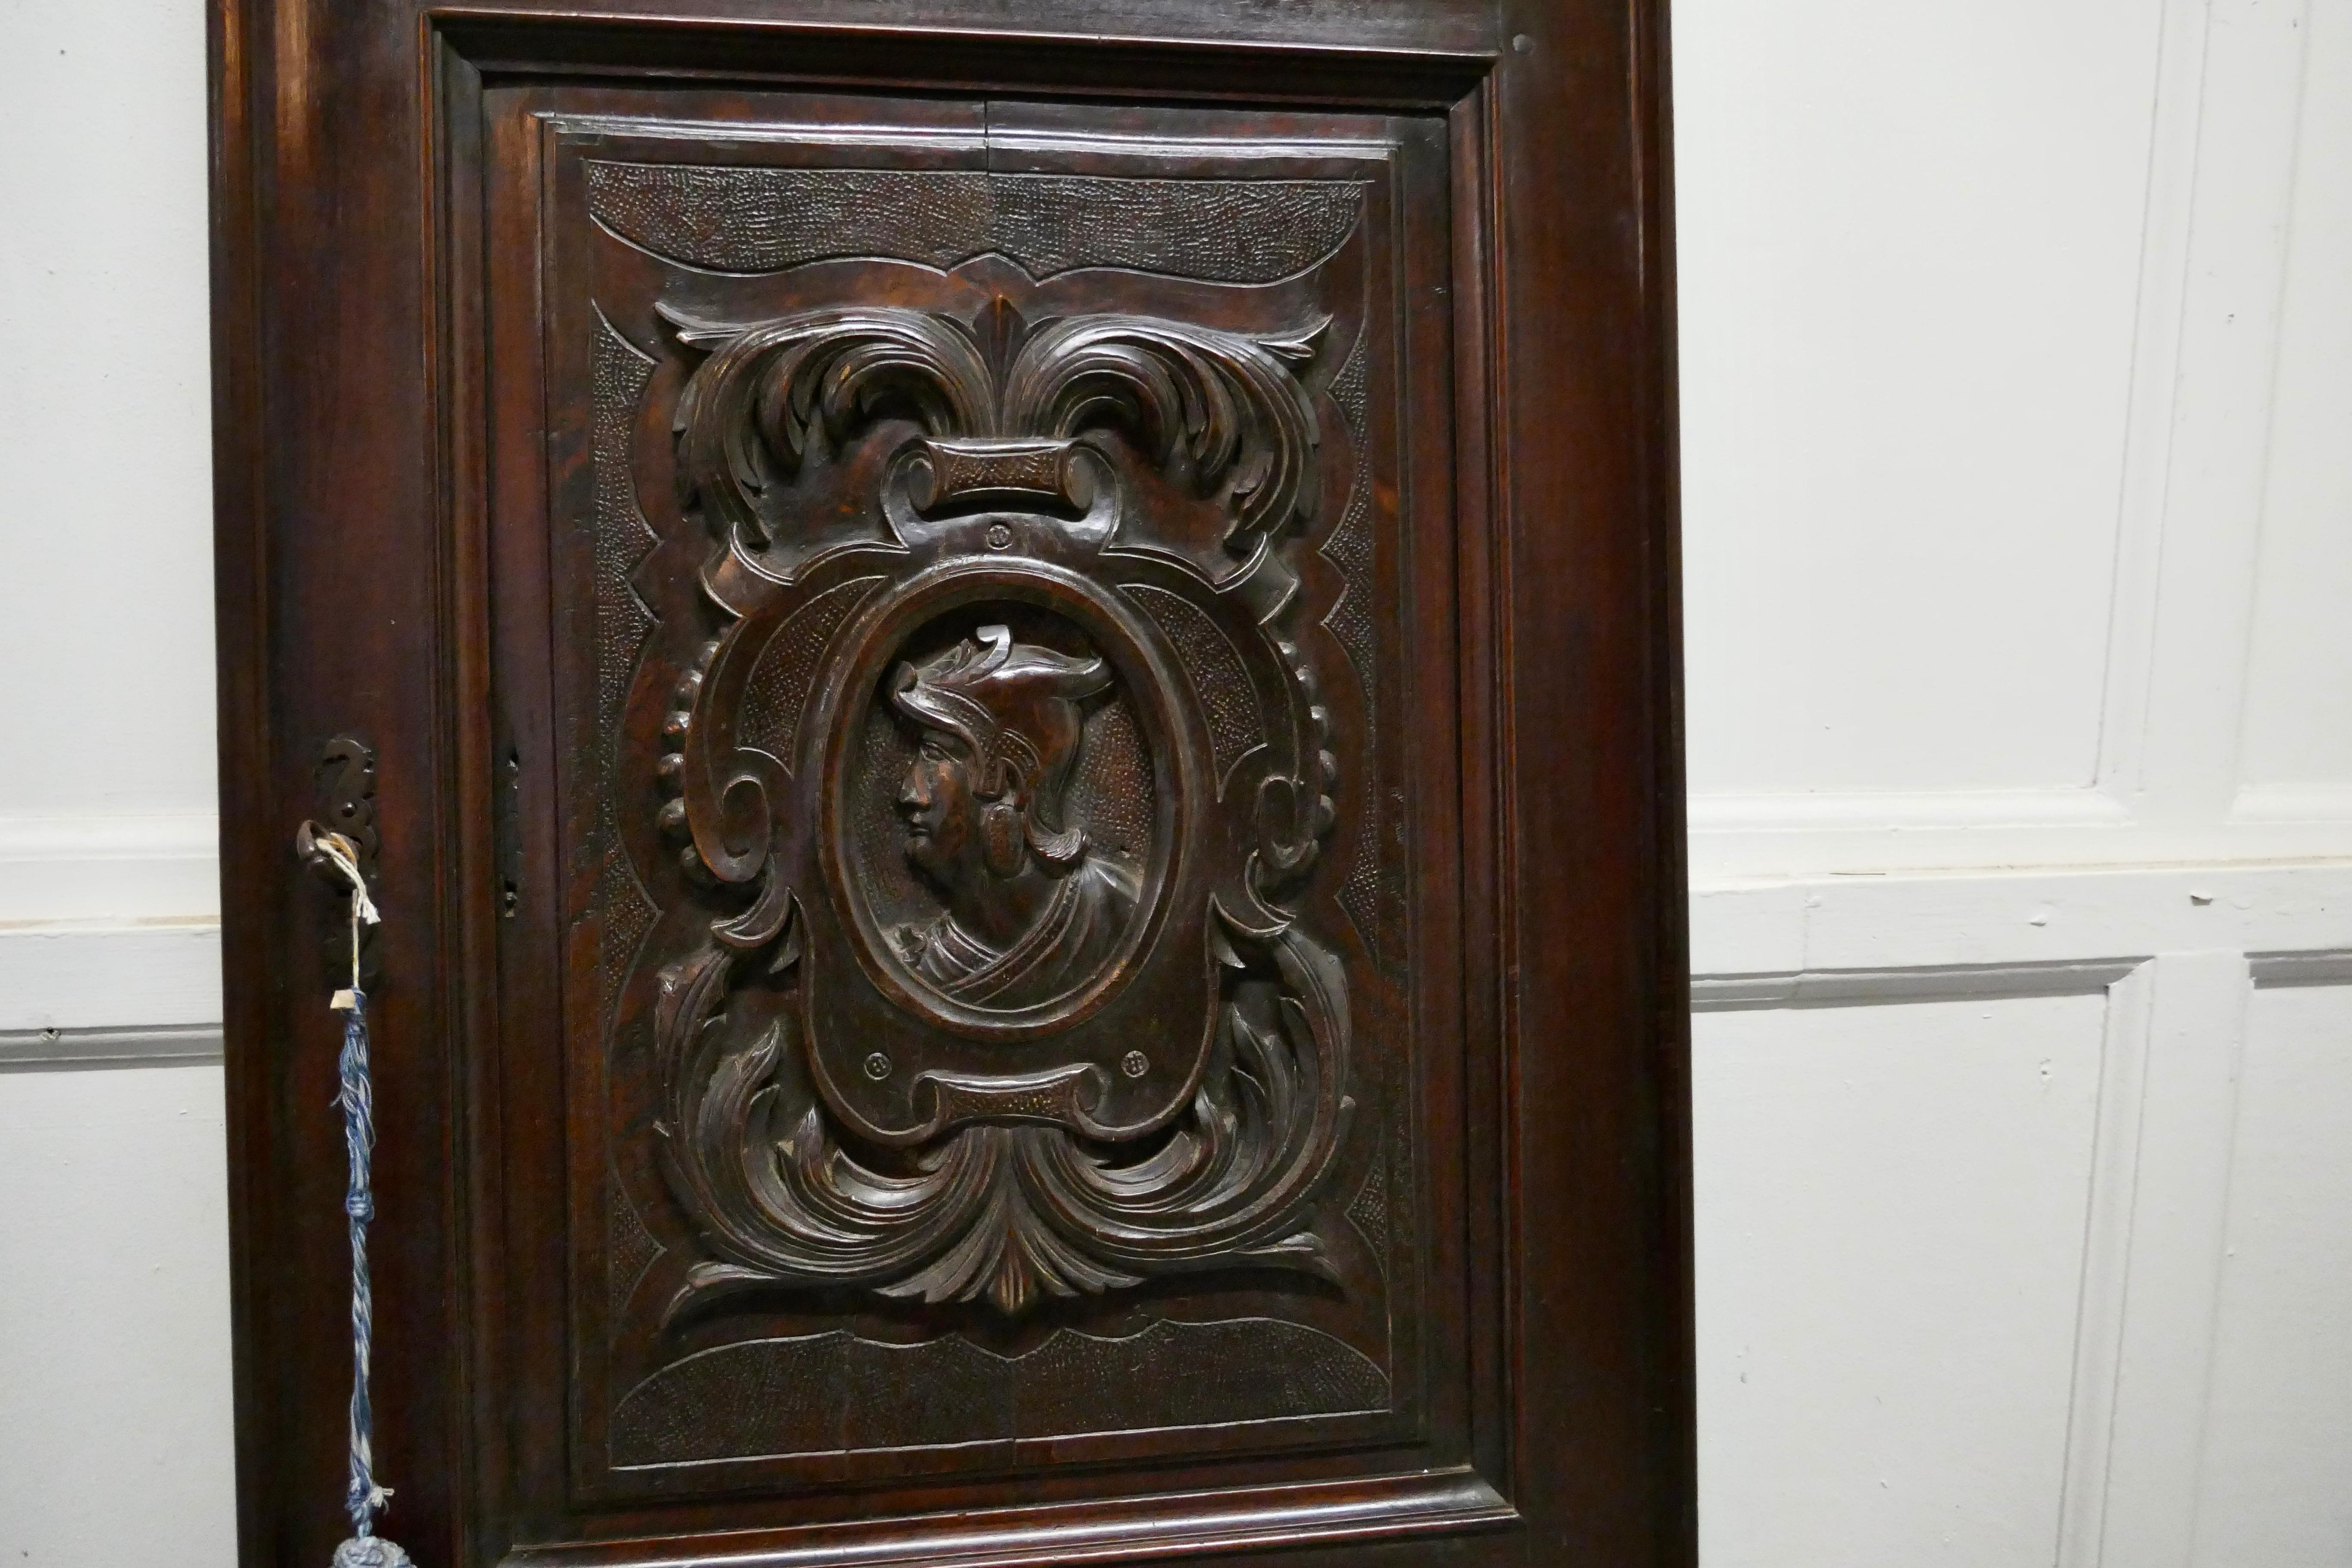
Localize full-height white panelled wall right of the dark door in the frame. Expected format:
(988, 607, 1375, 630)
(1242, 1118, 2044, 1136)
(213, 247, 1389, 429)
(1675, 0, 2352, 1568)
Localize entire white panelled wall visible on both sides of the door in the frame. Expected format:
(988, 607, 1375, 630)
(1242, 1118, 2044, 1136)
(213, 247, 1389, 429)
(0, 0, 2352, 1568)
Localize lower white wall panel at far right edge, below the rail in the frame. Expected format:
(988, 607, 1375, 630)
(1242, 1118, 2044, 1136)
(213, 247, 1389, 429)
(2194, 985, 2352, 1568)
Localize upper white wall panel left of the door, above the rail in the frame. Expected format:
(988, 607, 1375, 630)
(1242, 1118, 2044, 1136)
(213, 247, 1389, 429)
(0, 0, 214, 832)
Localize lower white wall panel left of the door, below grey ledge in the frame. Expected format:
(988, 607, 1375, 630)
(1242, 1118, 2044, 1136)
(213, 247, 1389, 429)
(0, 1067, 238, 1568)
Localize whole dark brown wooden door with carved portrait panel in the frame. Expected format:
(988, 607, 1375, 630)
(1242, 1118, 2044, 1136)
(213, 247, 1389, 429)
(214, 0, 1691, 1568)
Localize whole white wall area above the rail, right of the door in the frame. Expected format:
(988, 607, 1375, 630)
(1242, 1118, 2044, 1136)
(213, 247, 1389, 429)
(1675, 0, 2352, 877)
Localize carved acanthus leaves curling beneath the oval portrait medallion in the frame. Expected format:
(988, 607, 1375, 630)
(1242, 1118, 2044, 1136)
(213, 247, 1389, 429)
(656, 910, 1355, 1314)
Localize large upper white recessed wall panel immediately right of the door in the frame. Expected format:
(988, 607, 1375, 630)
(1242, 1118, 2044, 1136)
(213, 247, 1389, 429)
(1675, 0, 2162, 795)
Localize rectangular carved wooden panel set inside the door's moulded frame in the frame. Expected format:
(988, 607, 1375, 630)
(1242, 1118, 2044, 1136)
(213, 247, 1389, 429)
(543, 115, 1425, 1493)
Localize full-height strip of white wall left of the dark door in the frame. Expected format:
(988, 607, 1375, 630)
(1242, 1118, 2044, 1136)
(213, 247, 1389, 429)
(0, 0, 235, 1568)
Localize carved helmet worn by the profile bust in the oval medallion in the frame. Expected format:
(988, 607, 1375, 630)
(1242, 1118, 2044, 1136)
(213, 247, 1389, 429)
(889, 625, 1110, 875)
